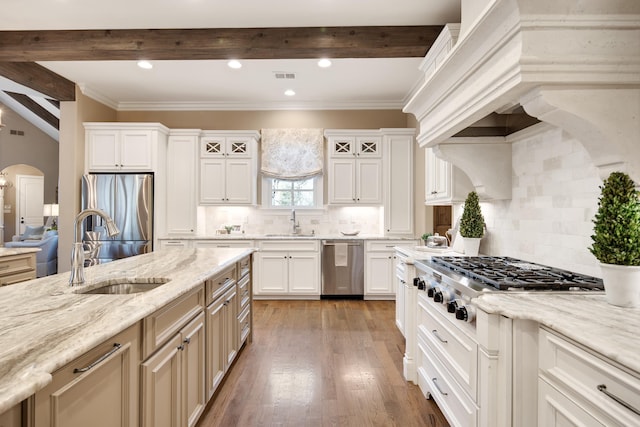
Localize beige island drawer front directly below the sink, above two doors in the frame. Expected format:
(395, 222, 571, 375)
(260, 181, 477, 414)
(142, 286, 204, 359)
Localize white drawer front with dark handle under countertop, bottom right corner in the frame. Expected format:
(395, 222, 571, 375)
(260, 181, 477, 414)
(538, 328, 640, 426)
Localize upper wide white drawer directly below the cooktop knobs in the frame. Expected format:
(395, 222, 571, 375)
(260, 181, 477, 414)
(418, 292, 478, 400)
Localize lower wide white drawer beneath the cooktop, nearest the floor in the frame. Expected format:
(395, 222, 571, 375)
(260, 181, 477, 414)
(417, 336, 478, 427)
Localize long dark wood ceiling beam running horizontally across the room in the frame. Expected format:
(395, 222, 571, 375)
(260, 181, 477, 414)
(0, 25, 443, 62)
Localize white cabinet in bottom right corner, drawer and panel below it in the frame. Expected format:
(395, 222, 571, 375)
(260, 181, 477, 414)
(538, 327, 640, 427)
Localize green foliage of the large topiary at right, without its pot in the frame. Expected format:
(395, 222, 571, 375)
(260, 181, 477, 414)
(589, 172, 640, 266)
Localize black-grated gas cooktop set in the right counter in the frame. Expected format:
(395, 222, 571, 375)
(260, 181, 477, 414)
(431, 256, 604, 291)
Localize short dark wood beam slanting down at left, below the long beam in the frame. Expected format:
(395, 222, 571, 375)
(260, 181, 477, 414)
(0, 61, 76, 101)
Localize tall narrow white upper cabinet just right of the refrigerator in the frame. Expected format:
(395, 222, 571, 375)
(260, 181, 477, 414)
(166, 129, 200, 236)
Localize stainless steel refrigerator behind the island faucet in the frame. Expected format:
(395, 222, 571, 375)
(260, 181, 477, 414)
(82, 174, 153, 265)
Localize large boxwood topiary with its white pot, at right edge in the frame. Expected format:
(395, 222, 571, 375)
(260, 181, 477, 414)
(589, 172, 640, 307)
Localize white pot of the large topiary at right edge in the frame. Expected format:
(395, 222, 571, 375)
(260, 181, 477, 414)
(600, 263, 640, 307)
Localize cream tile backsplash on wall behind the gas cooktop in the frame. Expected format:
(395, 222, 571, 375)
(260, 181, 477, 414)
(454, 125, 602, 277)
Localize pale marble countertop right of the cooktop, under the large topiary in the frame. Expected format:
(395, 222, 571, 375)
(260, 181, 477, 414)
(473, 292, 640, 375)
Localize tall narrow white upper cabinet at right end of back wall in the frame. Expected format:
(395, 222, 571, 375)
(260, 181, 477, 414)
(382, 129, 415, 237)
